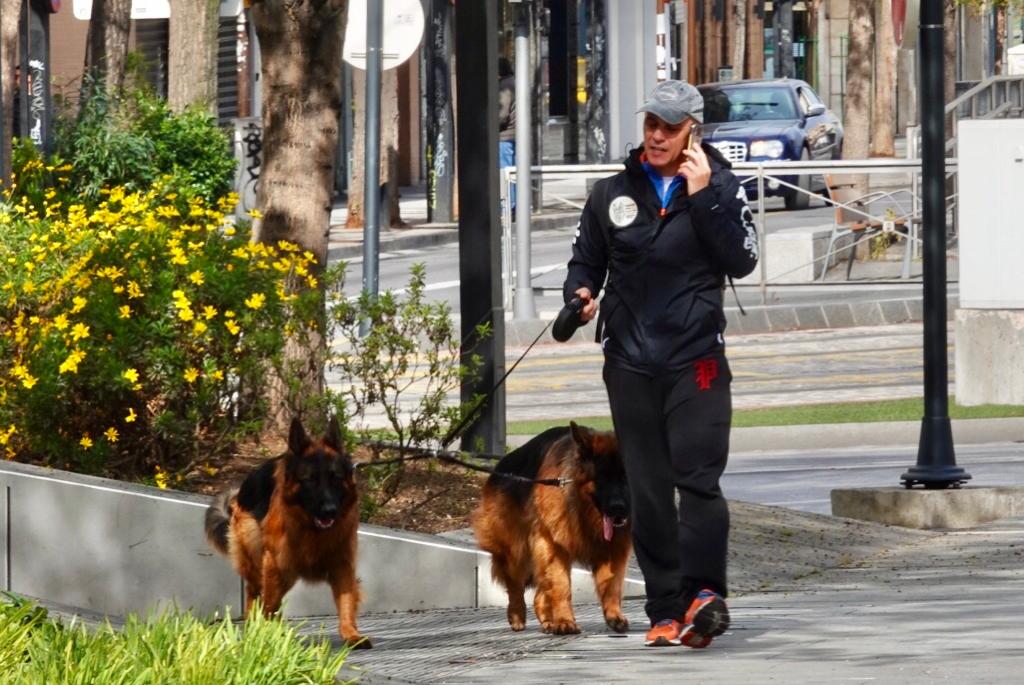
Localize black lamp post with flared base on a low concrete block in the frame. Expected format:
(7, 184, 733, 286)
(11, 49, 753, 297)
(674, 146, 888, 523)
(900, 0, 971, 489)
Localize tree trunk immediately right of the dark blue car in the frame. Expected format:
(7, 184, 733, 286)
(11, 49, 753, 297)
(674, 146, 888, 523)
(843, 0, 872, 183)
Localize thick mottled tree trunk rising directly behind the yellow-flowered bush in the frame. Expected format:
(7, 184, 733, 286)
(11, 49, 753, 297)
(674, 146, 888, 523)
(252, 0, 348, 430)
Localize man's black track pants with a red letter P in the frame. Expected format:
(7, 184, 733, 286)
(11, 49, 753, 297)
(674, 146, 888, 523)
(604, 353, 732, 625)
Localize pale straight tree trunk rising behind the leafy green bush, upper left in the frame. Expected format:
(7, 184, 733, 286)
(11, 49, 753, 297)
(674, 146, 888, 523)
(167, 0, 220, 114)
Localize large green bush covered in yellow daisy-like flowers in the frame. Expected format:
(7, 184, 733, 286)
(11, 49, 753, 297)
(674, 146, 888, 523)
(0, 174, 323, 484)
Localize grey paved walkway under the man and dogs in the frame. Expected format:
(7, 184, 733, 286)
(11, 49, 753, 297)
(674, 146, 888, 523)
(329, 502, 1024, 684)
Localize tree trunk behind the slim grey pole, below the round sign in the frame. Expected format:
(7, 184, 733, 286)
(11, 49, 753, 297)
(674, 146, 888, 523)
(345, 69, 409, 228)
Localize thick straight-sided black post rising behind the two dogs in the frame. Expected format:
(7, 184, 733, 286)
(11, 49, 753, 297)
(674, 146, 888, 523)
(455, 0, 505, 454)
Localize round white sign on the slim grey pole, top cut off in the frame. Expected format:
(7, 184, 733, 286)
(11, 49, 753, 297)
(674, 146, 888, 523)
(343, 0, 423, 70)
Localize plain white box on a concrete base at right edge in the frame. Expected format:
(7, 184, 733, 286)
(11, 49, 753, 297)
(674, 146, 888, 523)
(956, 119, 1024, 309)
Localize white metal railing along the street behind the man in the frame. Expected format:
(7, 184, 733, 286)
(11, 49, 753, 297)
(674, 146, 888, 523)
(500, 159, 956, 308)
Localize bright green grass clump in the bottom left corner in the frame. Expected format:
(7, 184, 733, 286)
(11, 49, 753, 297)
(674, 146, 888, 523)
(0, 598, 347, 685)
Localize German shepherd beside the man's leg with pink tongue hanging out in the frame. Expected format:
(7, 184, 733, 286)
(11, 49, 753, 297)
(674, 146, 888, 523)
(473, 423, 632, 635)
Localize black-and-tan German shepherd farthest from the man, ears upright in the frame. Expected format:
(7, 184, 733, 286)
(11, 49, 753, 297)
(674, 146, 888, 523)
(206, 418, 371, 648)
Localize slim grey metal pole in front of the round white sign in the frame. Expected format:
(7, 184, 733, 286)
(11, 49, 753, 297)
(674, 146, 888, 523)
(362, 2, 384, 305)
